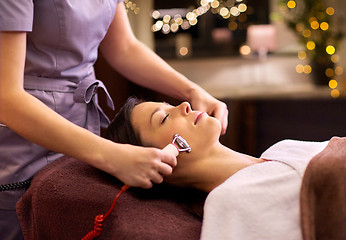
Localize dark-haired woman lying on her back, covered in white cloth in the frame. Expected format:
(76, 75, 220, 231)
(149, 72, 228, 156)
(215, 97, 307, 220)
(107, 98, 344, 240)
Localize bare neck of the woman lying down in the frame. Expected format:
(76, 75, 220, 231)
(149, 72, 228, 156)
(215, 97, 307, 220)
(168, 144, 262, 192)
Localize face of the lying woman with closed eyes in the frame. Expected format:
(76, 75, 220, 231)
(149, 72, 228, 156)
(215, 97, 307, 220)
(130, 102, 221, 152)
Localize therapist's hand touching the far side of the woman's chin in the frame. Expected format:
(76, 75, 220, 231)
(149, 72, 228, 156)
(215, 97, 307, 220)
(190, 90, 228, 135)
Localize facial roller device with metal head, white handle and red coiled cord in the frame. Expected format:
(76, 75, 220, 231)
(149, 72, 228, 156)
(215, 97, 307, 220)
(82, 134, 191, 240)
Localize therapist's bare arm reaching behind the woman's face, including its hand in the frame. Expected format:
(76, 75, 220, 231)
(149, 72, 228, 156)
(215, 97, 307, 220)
(100, 3, 228, 133)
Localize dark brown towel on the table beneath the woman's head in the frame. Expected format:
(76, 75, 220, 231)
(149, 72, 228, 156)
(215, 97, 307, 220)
(17, 157, 201, 240)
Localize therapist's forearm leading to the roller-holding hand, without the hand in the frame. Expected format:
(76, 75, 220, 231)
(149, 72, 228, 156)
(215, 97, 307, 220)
(0, 90, 111, 168)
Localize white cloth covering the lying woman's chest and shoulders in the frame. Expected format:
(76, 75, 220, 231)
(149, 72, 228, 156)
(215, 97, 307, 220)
(201, 140, 328, 240)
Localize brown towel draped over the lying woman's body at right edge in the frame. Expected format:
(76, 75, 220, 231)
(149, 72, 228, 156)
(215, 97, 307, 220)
(300, 137, 346, 240)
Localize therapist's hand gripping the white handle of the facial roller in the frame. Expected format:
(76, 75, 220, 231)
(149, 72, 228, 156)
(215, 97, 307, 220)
(114, 144, 177, 189)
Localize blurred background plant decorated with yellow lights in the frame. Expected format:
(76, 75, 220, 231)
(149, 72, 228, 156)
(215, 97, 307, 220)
(279, 0, 343, 89)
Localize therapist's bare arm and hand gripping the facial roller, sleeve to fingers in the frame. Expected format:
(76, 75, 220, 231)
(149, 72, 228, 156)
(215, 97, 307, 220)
(0, 32, 176, 188)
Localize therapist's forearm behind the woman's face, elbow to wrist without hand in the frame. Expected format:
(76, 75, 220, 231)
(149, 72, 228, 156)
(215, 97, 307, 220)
(100, 41, 203, 100)
